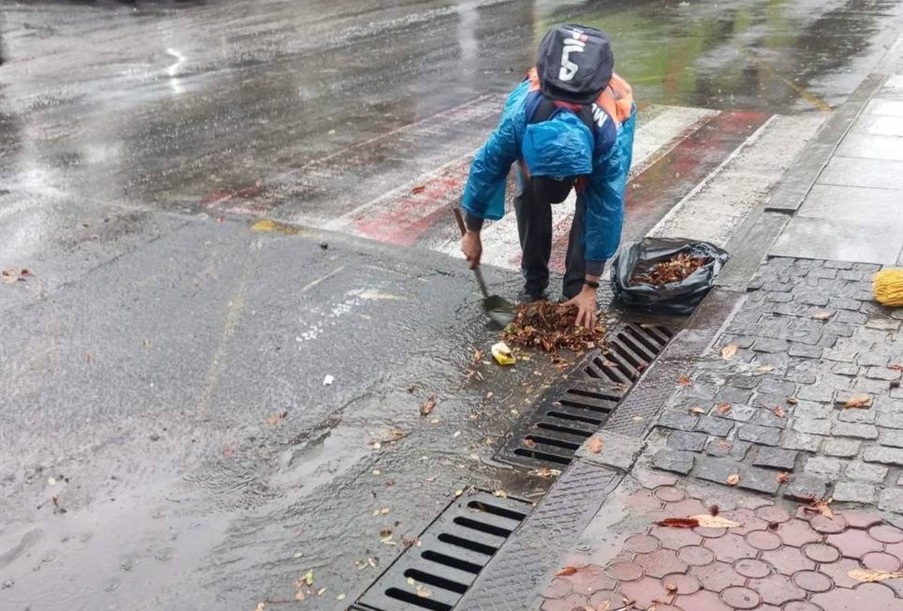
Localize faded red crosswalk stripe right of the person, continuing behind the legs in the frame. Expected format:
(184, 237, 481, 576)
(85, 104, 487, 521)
(549, 110, 771, 273)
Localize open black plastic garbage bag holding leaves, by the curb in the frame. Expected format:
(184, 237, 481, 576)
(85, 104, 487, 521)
(611, 238, 730, 314)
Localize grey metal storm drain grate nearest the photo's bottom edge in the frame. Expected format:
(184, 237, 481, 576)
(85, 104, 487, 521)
(352, 491, 532, 611)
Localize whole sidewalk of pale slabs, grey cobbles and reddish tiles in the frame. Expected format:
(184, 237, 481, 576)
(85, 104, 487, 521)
(533, 59, 903, 611)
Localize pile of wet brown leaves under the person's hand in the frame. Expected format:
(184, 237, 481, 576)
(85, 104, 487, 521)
(502, 301, 605, 354)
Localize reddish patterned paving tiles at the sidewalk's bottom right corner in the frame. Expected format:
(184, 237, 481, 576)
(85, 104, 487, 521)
(537, 467, 903, 611)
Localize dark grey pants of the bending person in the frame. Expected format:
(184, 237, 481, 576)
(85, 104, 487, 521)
(514, 174, 586, 299)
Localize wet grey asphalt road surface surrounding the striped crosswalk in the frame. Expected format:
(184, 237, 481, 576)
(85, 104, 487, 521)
(0, 0, 901, 611)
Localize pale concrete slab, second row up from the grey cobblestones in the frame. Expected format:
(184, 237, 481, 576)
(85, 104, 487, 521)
(799, 185, 903, 222)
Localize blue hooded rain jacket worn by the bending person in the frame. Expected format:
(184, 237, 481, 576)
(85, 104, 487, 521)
(462, 80, 636, 267)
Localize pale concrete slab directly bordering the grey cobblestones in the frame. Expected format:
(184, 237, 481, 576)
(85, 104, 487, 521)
(769, 216, 903, 265)
